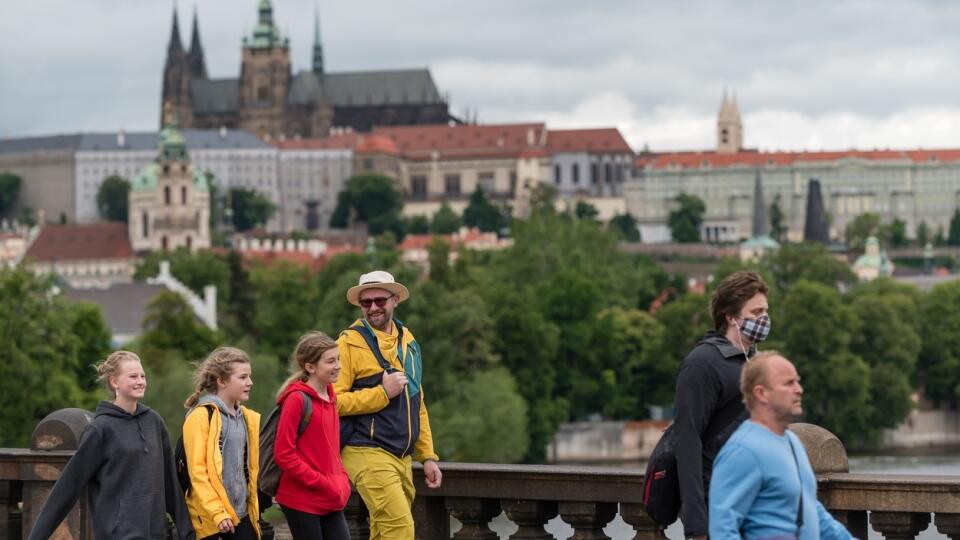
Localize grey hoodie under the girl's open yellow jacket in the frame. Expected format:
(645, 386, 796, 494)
(188, 394, 250, 519)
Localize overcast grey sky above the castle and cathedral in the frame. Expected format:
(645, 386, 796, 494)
(0, 0, 960, 151)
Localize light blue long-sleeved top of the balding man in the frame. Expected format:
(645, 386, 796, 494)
(708, 420, 853, 540)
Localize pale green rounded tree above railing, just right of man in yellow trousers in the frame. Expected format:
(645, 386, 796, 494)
(430, 368, 530, 463)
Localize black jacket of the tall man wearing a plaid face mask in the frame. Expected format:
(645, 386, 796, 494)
(673, 331, 747, 537)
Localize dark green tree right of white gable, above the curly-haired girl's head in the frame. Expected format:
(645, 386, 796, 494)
(138, 290, 220, 371)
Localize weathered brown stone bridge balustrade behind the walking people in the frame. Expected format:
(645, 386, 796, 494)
(0, 416, 960, 540)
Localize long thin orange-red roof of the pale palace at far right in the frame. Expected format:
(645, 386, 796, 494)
(634, 149, 960, 169)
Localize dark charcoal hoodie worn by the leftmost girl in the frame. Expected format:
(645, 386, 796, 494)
(30, 401, 194, 540)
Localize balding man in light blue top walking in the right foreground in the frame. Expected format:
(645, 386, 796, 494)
(708, 351, 852, 540)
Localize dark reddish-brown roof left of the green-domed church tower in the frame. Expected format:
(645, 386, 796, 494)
(26, 223, 133, 262)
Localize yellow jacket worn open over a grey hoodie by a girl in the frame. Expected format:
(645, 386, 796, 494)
(183, 403, 260, 538)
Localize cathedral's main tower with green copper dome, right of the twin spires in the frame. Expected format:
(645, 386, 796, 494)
(239, 0, 291, 138)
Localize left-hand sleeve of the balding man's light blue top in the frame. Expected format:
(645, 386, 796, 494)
(708, 444, 763, 540)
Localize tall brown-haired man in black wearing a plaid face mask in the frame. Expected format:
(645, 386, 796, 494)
(673, 271, 770, 539)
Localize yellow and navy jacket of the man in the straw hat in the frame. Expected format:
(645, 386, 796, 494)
(334, 319, 439, 461)
